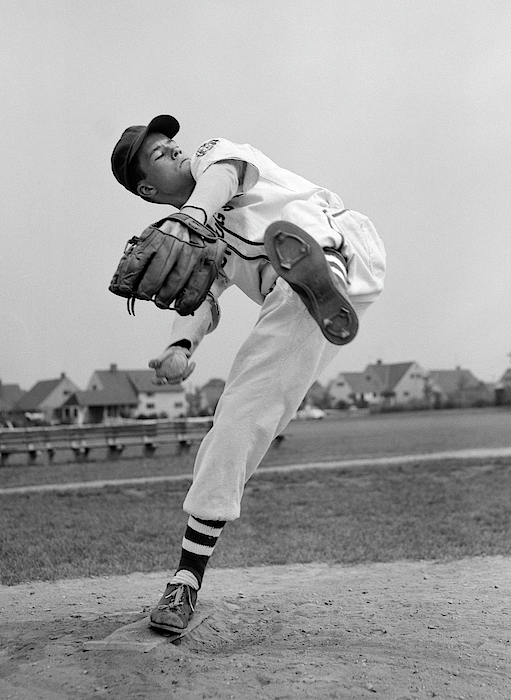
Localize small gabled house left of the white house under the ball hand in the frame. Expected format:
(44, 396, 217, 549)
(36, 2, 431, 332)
(11, 372, 79, 423)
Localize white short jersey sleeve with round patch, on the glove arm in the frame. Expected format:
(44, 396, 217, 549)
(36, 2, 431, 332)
(191, 139, 259, 196)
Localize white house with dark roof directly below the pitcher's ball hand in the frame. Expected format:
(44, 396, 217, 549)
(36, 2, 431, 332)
(66, 364, 186, 424)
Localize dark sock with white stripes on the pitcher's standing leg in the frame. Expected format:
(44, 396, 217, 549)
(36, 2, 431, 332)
(171, 515, 226, 590)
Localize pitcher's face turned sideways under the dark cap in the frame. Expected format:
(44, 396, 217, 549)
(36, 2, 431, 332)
(138, 133, 195, 207)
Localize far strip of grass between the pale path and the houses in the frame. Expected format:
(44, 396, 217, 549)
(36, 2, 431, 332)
(0, 407, 511, 488)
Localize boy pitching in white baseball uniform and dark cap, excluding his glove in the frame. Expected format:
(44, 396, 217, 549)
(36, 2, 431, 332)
(111, 115, 385, 632)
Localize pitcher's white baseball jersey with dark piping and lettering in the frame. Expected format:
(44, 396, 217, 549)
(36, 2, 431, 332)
(191, 138, 383, 304)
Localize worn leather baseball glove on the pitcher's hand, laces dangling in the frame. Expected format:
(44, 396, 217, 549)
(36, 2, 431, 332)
(109, 212, 227, 316)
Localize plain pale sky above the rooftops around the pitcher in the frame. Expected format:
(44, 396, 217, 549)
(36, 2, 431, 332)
(0, 0, 511, 390)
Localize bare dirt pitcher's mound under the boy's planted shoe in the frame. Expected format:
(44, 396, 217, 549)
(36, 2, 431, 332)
(0, 557, 511, 700)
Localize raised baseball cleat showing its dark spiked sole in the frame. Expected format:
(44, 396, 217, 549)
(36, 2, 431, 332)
(264, 221, 358, 345)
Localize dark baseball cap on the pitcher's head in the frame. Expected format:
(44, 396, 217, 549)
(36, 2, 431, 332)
(111, 114, 179, 194)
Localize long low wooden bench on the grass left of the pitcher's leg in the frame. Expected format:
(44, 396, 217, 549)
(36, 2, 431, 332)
(0, 419, 211, 465)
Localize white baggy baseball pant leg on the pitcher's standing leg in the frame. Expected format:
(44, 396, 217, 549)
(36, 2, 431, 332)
(183, 278, 370, 520)
